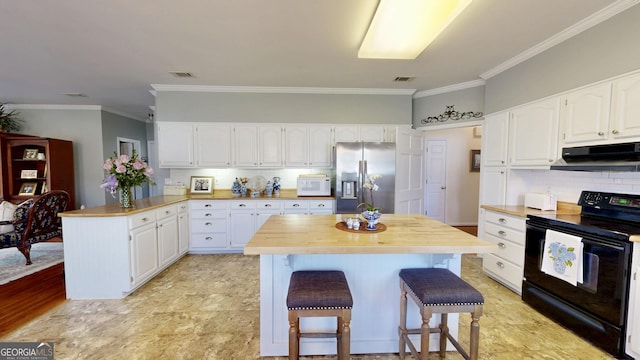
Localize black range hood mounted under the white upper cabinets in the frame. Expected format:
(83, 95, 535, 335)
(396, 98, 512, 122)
(551, 142, 640, 171)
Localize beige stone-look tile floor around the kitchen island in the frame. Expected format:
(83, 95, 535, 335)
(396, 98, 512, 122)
(0, 254, 612, 360)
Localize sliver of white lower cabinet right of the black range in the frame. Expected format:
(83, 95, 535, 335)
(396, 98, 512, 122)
(625, 243, 640, 359)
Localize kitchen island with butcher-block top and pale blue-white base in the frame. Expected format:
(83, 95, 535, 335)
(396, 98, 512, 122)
(244, 214, 497, 356)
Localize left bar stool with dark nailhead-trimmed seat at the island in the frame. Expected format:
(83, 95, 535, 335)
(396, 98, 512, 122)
(287, 270, 353, 360)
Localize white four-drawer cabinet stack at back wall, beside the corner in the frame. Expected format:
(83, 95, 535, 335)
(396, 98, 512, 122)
(189, 200, 229, 253)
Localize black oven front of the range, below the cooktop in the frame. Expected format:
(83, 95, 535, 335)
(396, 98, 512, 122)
(522, 220, 631, 355)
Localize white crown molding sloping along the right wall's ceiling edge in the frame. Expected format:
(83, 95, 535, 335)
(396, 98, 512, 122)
(480, 0, 640, 80)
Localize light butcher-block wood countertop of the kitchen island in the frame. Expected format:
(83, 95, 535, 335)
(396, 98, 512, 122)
(244, 214, 498, 255)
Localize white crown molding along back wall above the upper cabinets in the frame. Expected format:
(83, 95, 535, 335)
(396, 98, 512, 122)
(151, 84, 416, 95)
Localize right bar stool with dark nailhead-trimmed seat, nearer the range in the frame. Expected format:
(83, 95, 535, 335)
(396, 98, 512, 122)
(398, 268, 484, 360)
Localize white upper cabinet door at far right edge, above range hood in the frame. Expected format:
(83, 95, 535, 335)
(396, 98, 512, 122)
(610, 74, 640, 139)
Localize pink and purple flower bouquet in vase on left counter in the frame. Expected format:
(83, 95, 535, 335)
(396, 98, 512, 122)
(100, 150, 154, 198)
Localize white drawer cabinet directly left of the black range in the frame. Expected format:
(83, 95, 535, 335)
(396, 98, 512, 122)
(482, 210, 526, 294)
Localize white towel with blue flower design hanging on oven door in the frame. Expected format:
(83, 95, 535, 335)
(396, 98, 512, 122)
(540, 230, 583, 286)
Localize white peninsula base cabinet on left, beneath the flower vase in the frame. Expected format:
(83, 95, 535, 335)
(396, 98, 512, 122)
(62, 202, 186, 300)
